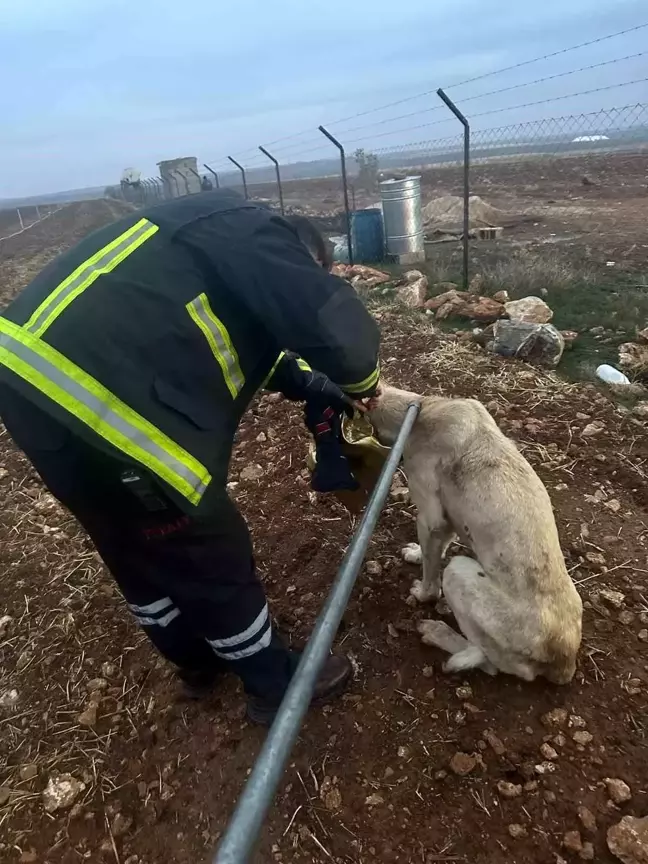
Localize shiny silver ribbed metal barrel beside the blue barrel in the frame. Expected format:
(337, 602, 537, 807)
(380, 177, 425, 257)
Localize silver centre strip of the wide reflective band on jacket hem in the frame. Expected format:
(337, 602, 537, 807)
(0, 332, 207, 497)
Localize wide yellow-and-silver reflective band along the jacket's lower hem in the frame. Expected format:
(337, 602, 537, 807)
(0, 318, 211, 504)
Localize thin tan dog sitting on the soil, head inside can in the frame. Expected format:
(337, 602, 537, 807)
(368, 386, 583, 684)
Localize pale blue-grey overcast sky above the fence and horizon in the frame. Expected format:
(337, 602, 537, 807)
(0, 0, 648, 198)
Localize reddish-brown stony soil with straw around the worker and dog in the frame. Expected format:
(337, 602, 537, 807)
(0, 191, 648, 864)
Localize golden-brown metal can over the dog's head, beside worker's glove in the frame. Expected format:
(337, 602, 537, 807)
(307, 413, 389, 513)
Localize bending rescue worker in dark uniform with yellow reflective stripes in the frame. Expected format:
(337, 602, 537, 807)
(0, 191, 379, 724)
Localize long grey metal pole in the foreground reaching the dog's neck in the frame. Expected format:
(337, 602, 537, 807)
(213, 403, 420, 864)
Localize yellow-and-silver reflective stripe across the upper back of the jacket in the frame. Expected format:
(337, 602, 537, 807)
(25, 219, 159, 336)
